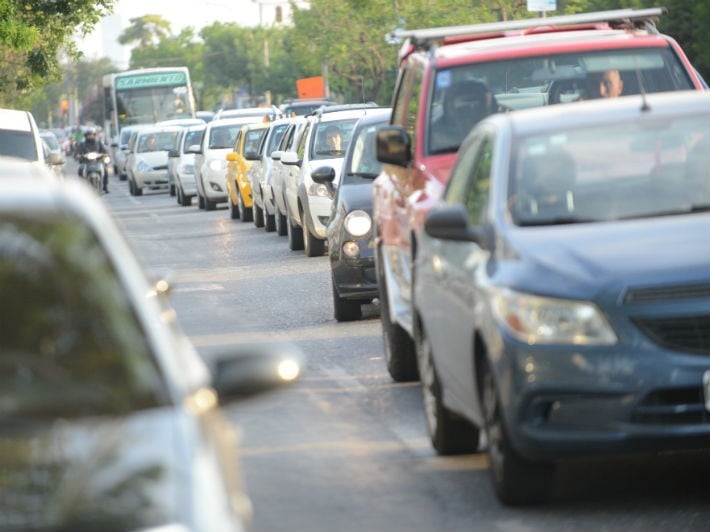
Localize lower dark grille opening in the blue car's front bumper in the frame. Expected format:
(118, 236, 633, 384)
(631, 386, 710, 425)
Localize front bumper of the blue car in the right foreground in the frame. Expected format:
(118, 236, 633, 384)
(498, 331, 710, 460)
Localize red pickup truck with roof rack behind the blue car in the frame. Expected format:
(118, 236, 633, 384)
(373, 8, 704, 381)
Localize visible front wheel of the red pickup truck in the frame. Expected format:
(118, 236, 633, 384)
(377, 244, 419, 382)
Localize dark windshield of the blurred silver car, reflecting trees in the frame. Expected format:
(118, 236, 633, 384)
(0, 217, 169, 420)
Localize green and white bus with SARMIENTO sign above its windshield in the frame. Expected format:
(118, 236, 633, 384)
(103, 67, 195, 141)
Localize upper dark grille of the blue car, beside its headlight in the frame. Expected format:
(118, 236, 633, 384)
(632, 314, 710, 356)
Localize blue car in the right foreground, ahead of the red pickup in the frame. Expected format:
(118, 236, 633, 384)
(413, 92, 710, 504)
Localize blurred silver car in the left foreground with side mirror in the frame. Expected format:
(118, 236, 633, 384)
(0, 160, 301, 532)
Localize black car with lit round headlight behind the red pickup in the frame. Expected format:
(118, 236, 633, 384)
(313, 108, 391, 321)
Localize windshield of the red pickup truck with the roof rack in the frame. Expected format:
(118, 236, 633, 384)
(426, 48, 693, 154)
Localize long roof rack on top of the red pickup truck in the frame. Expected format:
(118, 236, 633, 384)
(388, 7, 667, 47)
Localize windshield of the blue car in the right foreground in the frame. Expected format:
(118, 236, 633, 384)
(508, 113, 710, 225)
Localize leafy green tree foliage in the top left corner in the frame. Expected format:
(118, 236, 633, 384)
(0, 0, 115, 107)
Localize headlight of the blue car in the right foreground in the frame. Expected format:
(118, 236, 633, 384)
(491, 288, 617, 345)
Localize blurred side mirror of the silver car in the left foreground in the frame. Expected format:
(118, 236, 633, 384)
(206, 342, 305, 404)
